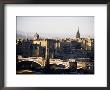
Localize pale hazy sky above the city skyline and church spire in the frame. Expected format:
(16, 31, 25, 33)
(16, 16, 94, 38)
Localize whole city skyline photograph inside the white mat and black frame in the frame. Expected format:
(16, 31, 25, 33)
(16, 16, 94, 74)
